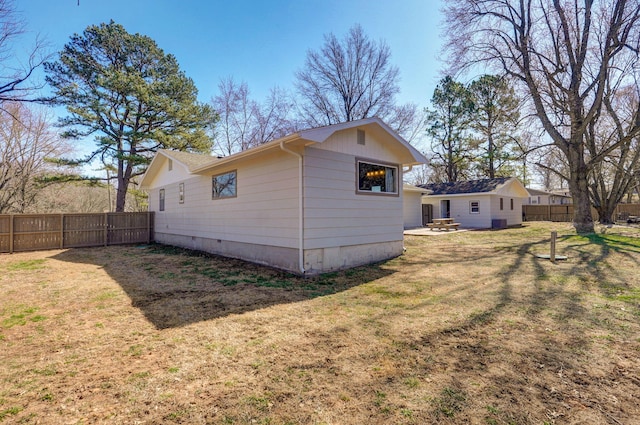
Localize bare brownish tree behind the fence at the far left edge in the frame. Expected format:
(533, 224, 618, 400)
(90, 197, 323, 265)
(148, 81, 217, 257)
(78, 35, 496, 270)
(0, 102, 68, 213)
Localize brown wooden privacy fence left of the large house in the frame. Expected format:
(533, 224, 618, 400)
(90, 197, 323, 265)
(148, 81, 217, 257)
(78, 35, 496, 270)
(0, 212, 153, 253)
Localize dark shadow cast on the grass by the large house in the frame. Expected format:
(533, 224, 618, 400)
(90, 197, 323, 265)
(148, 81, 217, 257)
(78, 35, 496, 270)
(53, 244, 393, 329)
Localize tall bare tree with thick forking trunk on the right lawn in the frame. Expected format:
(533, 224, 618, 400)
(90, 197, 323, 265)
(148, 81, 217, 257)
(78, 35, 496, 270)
(444, 0, 640, 232)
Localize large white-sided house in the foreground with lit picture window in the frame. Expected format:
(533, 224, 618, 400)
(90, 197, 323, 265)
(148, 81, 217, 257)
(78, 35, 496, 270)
(141, 118, 426, 275)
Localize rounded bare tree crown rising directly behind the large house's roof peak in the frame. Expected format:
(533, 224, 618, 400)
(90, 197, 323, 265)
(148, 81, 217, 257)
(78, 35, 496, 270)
(296, 25, 416, 133)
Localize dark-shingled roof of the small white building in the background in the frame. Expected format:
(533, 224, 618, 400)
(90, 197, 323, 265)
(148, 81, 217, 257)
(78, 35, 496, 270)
(419, 177, 529, 197)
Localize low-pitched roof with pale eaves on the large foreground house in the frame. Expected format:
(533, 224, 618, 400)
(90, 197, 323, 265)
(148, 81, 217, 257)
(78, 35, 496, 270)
(140, 117, 427, 189)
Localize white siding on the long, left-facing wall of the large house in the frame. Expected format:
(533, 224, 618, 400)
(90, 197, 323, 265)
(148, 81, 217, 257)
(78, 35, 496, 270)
(149, 152, 298, 248)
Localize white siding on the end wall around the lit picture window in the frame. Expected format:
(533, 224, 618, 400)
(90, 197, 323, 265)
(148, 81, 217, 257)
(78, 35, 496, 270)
(304, 147, 403, 249)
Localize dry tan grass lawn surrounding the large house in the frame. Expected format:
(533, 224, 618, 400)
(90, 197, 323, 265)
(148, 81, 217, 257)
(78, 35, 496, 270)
(0, 223, 640, 425)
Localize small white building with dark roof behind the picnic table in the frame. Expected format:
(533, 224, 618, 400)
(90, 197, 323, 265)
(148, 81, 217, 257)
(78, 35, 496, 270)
(419, 177, 529, 229)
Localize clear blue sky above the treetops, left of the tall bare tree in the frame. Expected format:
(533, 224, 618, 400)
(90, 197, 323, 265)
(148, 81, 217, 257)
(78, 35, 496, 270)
(16, 0, 442, 107)
